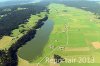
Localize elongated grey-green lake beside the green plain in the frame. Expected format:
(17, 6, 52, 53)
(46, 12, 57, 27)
(18, 20, 54, 61)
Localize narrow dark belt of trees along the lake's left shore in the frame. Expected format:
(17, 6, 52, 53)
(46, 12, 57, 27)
(0, 15, 48, 66)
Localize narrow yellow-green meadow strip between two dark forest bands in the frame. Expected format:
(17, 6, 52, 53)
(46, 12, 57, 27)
(0, 12, 46, 50)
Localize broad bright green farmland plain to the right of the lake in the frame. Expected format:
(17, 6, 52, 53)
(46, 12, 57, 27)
(19, 3, 100, 66)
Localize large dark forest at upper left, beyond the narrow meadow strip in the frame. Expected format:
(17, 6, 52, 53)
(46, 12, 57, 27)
(0, 3, 47, 37)
